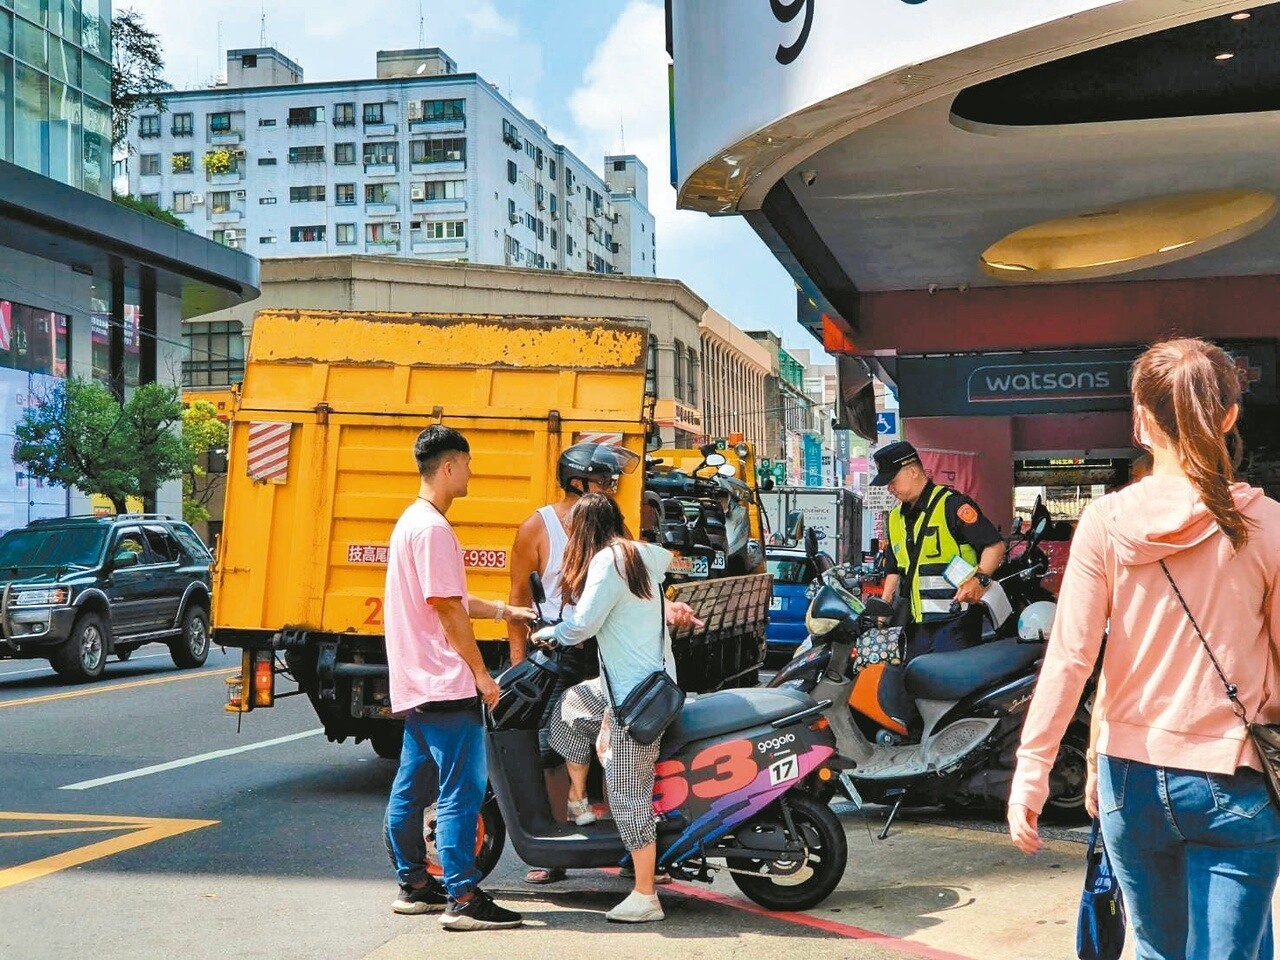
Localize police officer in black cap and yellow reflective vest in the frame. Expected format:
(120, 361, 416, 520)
(872, 440, 1005, 659)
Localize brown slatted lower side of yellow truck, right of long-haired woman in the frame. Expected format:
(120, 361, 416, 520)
(667, 573, 773, 694)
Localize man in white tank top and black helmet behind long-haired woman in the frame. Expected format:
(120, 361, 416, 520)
(507, 443, 701, 883)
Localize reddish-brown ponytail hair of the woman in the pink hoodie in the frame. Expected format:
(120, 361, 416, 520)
(1133, 337, 1249, 549)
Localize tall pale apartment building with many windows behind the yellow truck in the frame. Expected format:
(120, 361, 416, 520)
(127, 47, 655, 276)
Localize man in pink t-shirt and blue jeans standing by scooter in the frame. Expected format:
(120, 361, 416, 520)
(383, 425, 535, 931)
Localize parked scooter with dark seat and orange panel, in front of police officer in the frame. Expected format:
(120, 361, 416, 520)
(769, 512, 1092, 832)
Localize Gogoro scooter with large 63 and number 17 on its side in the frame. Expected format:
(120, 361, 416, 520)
(486, 575, 847, 910)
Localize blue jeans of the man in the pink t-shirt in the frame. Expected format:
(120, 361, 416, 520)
(387, 708, 489, 900)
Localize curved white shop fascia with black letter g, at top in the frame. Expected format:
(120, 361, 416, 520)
(671, 0, 1115, 193)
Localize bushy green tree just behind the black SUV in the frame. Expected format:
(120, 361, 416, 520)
(13, 378, 195, 513)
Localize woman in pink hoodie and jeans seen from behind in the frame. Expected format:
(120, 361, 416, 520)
(1009, 339, 1280, 960)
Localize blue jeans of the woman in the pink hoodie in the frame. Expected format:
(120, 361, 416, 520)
(1098, 756, 1280, 960)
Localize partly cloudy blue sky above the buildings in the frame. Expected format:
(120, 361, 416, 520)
(124, 0, 822, 358)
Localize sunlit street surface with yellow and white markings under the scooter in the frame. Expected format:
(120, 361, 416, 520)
(0, 646, 1100, 960)
